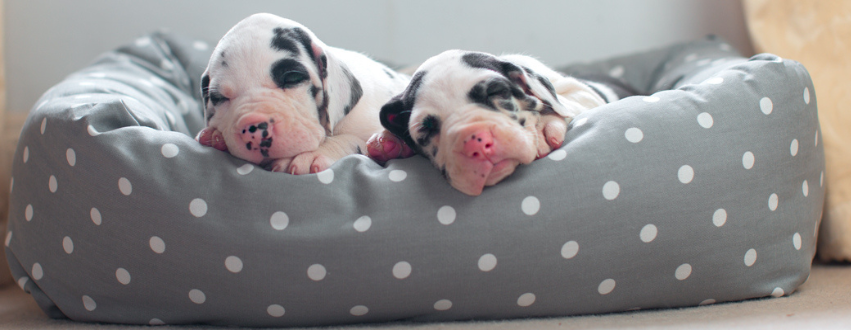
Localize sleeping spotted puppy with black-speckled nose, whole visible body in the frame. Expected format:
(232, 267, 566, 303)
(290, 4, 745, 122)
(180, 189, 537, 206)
(201, 14, 409, 174)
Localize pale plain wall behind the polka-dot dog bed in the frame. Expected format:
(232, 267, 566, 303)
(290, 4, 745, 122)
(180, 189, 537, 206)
(3, 0, 753, 112)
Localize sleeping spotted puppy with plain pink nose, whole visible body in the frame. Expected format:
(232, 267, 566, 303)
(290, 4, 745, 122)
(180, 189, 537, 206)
(368, 50, 635, 196)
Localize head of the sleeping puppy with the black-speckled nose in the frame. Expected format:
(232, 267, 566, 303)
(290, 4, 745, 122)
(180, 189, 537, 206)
(201, 14, 330, 164)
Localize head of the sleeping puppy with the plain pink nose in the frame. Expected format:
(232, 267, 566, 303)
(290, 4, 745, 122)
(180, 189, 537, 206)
(381, 50, 563, 196)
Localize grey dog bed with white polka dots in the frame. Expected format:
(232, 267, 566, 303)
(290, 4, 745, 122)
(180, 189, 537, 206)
(5, 34, 824, 326)
